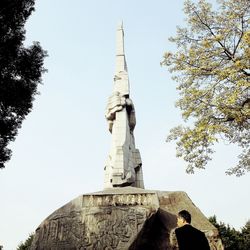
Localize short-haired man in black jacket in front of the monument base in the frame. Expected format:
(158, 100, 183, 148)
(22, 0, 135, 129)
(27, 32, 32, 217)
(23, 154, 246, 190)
(175, 210, 210, 250)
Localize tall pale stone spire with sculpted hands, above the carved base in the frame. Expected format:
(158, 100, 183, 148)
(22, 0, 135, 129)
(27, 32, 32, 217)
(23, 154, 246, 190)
(104, 23, 144, 188)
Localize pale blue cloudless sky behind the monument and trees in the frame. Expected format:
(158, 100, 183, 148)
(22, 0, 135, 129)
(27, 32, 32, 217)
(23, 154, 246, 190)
(0, 0, 250, 250)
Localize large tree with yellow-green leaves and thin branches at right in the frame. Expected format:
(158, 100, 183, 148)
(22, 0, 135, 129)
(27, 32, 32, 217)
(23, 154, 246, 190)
(162, 0, 250, 176)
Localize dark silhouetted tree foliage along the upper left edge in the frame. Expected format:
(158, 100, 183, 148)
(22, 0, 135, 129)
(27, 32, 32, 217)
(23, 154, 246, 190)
(0, 0, 46, 168)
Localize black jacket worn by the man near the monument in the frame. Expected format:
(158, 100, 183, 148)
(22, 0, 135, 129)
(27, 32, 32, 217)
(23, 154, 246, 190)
(175, 224, 210, 250)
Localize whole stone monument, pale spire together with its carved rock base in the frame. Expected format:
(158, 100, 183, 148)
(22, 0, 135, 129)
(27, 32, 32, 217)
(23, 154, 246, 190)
(31, 25, 223, 250)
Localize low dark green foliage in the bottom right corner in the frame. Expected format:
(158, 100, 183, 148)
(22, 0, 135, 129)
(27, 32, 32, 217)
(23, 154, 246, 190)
(209, 215, 250, 250)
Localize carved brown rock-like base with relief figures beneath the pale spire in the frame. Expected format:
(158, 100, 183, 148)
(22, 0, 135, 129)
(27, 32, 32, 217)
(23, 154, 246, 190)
(31, 187, 223, 250)
